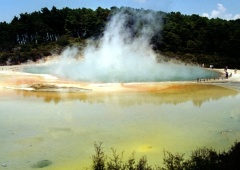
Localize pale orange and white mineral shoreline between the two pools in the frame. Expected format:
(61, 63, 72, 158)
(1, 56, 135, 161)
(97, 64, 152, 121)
(0, 64, 240, 92)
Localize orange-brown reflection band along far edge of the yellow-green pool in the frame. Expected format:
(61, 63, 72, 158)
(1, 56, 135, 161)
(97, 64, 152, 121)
(17, 84, 238, 106)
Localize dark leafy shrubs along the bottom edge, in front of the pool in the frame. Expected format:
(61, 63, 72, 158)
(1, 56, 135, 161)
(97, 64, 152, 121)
(90, 142, 240, 170)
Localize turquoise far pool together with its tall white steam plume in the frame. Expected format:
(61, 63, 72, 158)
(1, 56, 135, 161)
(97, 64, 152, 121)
(23, 9, 216, 82)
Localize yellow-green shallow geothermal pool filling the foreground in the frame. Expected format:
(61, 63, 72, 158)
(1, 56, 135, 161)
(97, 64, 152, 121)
(0, 81, 240, 170)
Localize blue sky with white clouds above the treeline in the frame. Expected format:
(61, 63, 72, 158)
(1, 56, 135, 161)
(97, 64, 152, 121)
(0, 0, 240, 23)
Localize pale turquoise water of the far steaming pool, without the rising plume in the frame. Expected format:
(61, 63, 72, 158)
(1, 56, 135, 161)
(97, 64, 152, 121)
(23, 61, 220, 83)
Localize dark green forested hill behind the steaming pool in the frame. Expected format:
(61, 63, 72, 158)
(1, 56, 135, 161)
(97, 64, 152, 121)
(0, 7, 240, 68)
